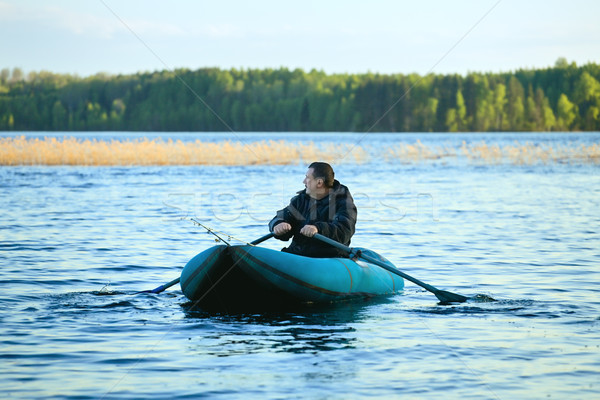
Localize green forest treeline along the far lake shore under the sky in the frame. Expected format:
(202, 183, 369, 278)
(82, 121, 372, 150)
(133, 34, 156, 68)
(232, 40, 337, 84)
(0, 59, 600, 132)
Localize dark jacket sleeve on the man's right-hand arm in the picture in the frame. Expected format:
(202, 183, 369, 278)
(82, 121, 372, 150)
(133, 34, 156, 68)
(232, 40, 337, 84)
(315, 192, 357, 246)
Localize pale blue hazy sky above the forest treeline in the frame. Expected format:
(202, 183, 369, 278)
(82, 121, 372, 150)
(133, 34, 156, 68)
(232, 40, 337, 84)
(0, 0, 600, 76)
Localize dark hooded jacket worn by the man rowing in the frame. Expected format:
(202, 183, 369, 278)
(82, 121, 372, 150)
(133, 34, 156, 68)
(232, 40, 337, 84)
(269, 180, 356, 257)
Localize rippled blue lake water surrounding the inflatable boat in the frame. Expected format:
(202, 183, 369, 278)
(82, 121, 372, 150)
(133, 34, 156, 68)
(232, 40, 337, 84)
(0, 133, 600, 399)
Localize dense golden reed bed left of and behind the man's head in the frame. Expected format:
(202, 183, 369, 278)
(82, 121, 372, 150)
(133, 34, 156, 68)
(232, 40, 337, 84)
(0, 136, 367, 166)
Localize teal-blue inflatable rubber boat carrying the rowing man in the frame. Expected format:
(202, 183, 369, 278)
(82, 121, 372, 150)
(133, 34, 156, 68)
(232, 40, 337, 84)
(181, 245, 404, 307)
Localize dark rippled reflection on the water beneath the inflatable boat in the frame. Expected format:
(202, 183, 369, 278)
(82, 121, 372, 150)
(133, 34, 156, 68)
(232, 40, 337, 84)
(182, 298, 394, 357)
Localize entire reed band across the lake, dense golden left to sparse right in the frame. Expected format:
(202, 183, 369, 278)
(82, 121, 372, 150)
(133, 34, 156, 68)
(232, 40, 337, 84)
(0, 136, 600, 166)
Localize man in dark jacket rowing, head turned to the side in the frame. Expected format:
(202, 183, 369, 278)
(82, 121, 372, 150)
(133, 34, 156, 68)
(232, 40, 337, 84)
(269, 162, 356, 257)
